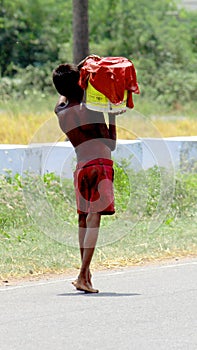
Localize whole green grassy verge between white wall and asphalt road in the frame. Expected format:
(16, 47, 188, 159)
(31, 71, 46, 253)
(0, 164, 197, 281)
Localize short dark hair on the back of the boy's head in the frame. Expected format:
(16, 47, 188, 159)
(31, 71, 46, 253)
(53, 63, 84, 102)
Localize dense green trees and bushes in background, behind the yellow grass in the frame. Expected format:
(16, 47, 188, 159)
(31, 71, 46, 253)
(0, 0, 197, 107)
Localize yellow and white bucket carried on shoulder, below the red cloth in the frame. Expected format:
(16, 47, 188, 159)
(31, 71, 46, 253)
(85, 82, 127, 113)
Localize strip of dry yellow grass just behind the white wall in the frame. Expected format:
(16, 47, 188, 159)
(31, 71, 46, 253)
(0, 110, 197, 144)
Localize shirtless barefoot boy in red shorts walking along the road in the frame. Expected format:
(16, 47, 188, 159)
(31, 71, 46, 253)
(53, 64, 116, 293)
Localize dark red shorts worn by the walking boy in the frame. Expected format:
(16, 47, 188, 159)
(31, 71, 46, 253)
(74, 158, 115, 215)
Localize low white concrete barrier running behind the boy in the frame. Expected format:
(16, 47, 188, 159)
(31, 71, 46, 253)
(0, 136, 197, 178)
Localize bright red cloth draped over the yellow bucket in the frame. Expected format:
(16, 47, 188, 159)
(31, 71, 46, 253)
(79, 56, 140, 108)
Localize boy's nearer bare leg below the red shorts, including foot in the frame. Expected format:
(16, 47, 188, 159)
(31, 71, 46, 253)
(75, 213, 101, 293)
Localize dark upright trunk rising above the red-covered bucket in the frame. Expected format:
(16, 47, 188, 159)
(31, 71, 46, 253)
(73, 0, 89, 64)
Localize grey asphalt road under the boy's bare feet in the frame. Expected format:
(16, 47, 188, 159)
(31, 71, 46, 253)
(0, 259, 197, 350)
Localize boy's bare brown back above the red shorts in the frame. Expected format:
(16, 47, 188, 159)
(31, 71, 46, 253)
(55, 103, 115, 162)
